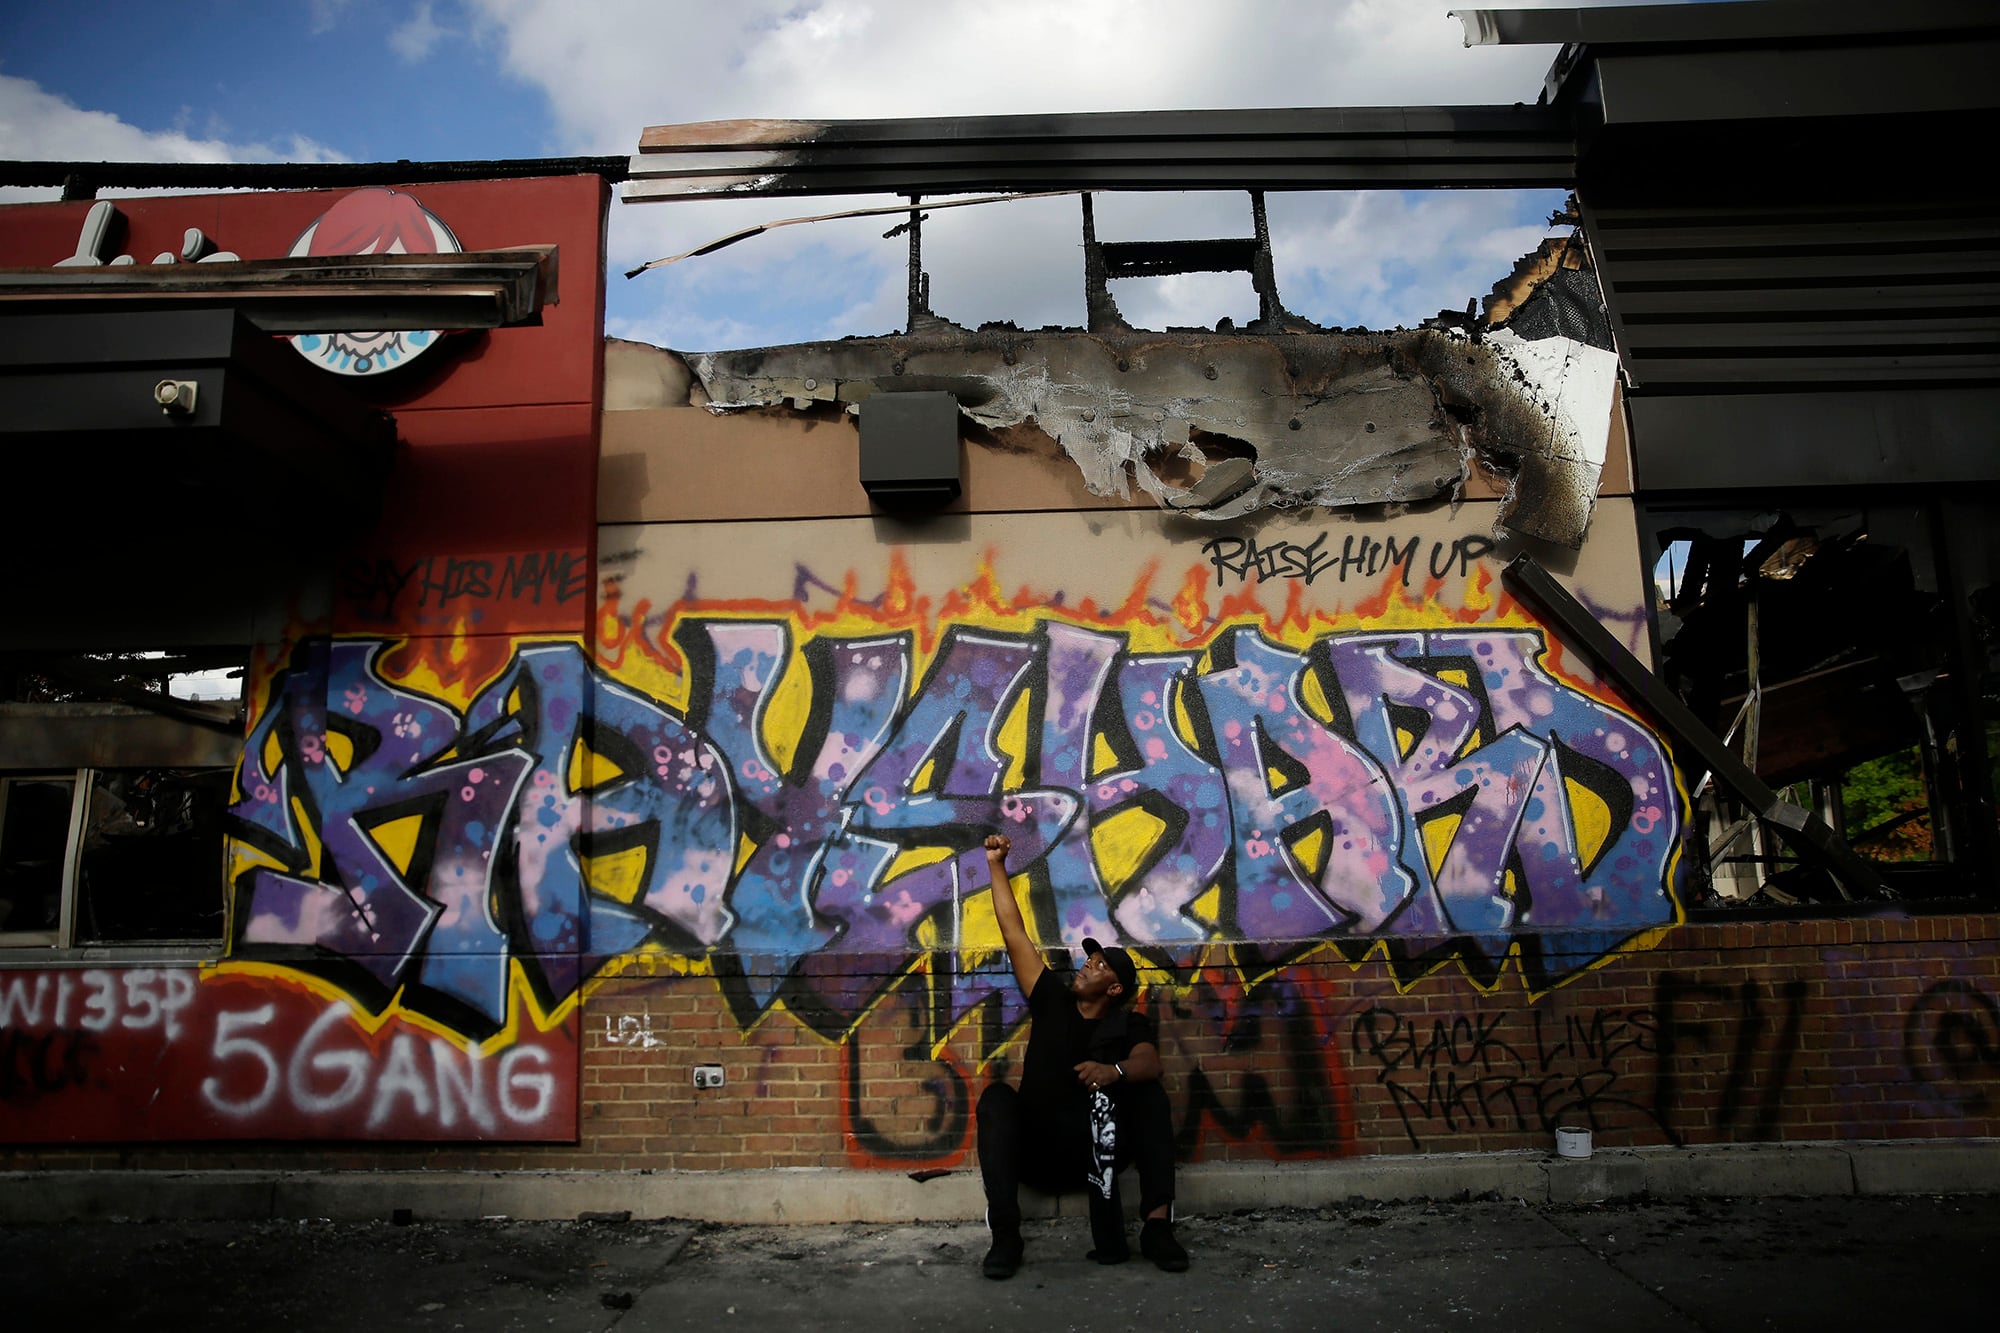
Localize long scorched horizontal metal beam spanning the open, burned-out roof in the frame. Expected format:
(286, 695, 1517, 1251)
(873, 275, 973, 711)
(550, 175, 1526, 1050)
(624, 106, 1576, 202)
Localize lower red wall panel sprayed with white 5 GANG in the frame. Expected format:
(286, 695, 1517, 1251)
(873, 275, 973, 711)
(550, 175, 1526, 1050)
(0, 967, 578, 1143)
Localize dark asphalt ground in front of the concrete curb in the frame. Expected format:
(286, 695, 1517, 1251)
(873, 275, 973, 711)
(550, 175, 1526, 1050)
(0, 1195, 2000, 1333)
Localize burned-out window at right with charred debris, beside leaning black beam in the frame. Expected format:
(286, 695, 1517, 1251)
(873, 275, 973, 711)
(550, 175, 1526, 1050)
(1638, 488, 2000, 921)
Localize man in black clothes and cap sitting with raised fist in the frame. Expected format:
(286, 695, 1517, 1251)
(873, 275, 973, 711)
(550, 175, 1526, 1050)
(978, 835, 1188, 1277)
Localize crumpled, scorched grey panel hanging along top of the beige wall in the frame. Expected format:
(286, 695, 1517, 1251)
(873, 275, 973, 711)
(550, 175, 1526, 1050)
(688, 326, 1614, 546)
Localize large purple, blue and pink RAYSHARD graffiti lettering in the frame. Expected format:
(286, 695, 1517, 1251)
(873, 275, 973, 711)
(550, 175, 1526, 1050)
(234, 616, 1680, 1037)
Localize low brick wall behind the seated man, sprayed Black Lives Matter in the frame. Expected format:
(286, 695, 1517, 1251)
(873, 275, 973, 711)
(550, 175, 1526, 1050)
(11, 915, 2000, 1171)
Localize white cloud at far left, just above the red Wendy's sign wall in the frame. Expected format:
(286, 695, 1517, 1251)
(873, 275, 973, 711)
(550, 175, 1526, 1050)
(0, 74, 346, 200)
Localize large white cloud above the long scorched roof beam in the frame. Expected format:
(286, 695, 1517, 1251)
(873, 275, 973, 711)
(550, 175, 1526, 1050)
(470, 0, 1554, 152)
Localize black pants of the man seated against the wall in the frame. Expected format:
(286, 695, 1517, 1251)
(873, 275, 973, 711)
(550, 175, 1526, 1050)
(978, 1081, 1174, 1249)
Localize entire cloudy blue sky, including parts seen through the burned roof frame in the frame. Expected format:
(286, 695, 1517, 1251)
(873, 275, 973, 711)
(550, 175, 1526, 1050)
(0, 0, 1656, 350)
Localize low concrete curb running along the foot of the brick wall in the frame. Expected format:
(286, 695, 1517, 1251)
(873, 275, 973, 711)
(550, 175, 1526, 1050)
(0, 1139, 2000, 1225)
